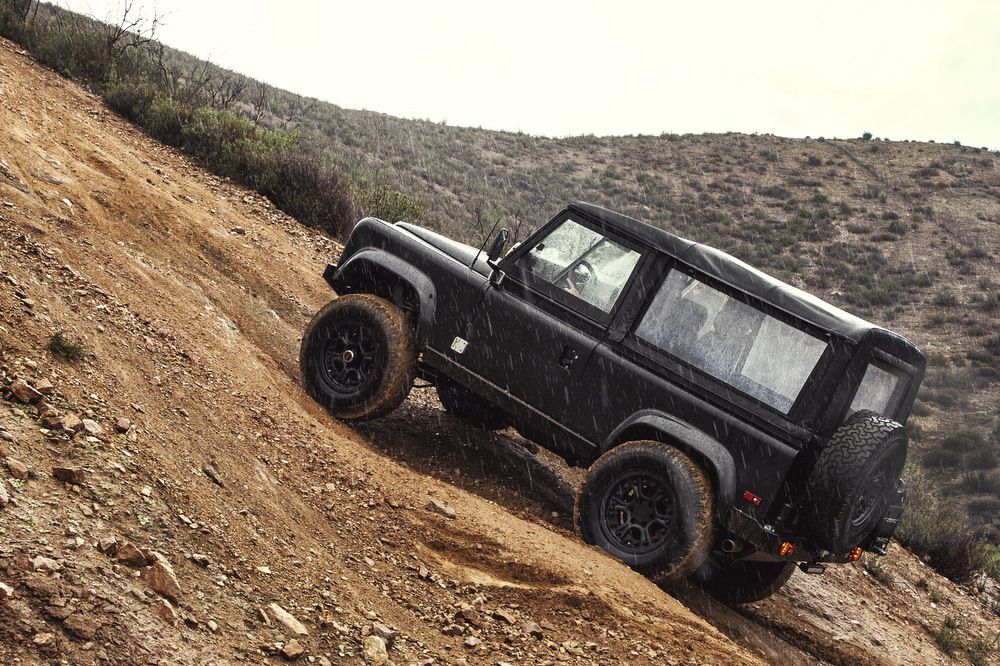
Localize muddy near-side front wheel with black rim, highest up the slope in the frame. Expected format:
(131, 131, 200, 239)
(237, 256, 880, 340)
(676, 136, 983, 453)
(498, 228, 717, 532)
(299, 294, 417, 421)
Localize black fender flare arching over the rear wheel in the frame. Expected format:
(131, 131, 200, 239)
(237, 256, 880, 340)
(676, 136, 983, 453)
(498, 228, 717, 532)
(601, 409, 736, 512)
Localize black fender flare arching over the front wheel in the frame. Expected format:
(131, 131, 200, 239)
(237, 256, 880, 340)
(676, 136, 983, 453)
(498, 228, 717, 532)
(329, 248, 437, 342)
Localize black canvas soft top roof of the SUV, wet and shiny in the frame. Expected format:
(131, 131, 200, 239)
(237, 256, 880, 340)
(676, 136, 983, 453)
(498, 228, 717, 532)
(569, 202, 885, 342)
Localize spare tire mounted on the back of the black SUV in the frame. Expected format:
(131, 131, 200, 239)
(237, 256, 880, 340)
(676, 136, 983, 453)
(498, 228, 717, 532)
(808, 411, 907, 555)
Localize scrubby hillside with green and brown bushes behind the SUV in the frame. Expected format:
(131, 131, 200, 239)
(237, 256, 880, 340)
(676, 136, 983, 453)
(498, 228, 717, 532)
(0, 2, 1000, 569)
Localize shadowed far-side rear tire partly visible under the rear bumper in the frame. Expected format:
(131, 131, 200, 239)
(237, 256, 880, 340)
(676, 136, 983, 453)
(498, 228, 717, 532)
(691, 551, 795, 604)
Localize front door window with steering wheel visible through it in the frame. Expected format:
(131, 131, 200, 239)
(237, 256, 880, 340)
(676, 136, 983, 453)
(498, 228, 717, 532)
(517, 220, 640, 312)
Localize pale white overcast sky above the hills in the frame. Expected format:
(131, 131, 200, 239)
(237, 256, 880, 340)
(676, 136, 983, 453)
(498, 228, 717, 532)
(57, 0, 1000, 148)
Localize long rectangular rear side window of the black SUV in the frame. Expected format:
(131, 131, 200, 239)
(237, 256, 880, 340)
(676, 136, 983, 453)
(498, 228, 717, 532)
(635, 271, 826, 414)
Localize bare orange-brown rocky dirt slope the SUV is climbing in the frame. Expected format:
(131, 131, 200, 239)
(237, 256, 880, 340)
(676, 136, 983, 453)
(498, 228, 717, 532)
(0, 37, 997, 664)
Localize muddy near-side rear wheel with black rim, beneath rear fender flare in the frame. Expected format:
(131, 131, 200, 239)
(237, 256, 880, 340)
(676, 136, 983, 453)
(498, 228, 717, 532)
(573, 441, 714, 583)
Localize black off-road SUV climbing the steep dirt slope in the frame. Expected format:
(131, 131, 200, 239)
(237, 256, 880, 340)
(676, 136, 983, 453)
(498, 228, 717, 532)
(301, 203, 925, 602)
